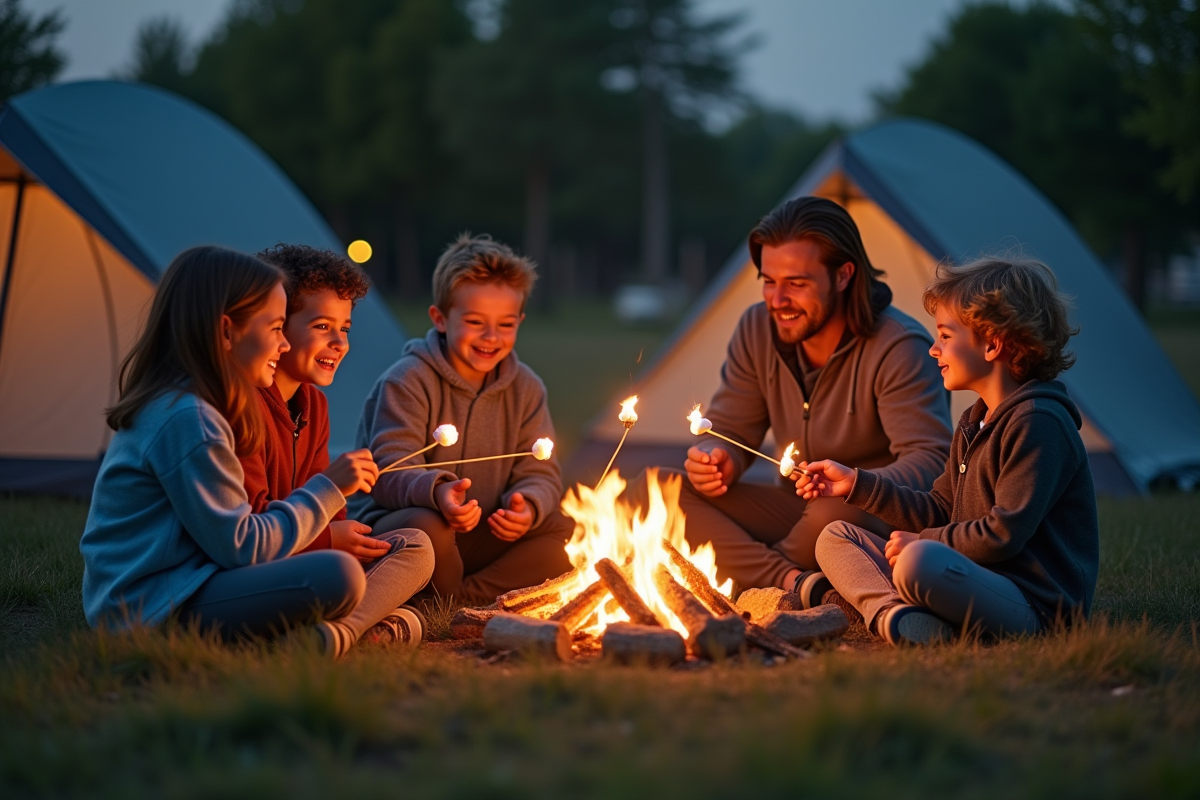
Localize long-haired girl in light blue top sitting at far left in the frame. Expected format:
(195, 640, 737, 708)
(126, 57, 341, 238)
(79, 247, 433, 657)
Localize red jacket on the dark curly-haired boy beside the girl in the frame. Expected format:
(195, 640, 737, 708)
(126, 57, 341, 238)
(240, 384, 346, 553)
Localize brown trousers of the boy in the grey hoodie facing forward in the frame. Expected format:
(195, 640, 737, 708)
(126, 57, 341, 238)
(374, 507, 575, 603)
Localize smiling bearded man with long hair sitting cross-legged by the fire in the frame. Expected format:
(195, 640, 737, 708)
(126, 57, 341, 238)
(680, 197, 950, 607)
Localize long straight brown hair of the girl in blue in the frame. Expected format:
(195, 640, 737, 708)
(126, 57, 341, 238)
(107, 247, 283, 456)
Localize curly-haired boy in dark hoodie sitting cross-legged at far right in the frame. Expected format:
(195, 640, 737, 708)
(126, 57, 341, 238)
(797, 258, 1099, 644)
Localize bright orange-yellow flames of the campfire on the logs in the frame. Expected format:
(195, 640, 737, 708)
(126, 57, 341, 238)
(563, 469, 733, 638)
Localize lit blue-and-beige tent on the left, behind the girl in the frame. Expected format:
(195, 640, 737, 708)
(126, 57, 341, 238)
(0, 80, 404, 494)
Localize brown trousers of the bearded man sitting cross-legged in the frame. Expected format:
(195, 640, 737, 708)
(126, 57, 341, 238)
(657, 469, 892, 589)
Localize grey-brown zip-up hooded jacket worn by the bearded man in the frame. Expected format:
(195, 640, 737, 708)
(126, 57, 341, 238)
(698, 284, 950, 489)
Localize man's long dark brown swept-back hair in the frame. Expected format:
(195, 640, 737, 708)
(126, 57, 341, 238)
(750, 197, 883, 338)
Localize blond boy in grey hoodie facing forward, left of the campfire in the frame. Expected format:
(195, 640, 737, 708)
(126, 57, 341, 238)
(350, 234, 574, 602)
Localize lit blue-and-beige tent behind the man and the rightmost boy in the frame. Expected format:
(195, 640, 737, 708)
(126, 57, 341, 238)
(569, 120, 1200, 493)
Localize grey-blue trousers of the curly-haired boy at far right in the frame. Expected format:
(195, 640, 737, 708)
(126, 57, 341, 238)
(816, 522, 1042, 636)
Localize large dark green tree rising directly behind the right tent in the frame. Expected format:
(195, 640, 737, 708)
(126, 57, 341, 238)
(878, 2, 1189, 268)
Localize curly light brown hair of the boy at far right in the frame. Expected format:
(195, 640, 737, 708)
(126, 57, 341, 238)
(922, 257, 1079, 384)
